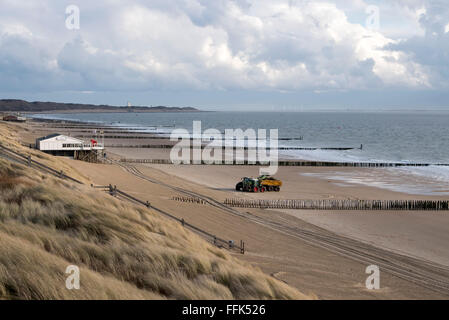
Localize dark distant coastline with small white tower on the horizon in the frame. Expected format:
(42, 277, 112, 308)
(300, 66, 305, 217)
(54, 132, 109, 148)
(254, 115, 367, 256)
(0, 99, 203, 113)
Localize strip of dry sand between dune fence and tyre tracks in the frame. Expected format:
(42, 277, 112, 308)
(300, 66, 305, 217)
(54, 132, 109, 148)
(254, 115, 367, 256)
(62, 160, 444, 299)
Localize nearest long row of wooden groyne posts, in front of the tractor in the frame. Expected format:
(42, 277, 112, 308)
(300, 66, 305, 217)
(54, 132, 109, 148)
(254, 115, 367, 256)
(224, 199, 449, 211)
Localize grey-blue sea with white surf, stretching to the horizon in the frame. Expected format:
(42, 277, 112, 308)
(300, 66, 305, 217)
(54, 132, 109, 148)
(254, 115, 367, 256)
(32, 111, 449, 195)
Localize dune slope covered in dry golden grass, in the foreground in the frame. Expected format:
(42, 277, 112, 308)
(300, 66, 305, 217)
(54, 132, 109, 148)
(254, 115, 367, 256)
(0, 124, 307, 299)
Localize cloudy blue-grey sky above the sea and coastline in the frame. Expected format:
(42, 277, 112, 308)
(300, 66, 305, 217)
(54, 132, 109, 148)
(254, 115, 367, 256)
(0, 0, 449, 111)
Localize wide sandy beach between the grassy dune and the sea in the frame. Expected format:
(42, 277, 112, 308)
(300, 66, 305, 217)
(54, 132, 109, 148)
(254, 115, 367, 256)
(13, 118, 449, 299)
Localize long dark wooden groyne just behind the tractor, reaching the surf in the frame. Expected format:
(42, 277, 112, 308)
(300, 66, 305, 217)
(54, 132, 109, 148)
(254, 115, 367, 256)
(120, 159, 449, 168)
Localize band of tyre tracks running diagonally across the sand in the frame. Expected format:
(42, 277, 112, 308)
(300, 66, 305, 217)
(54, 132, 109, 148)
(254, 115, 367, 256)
(117, 163, 449, 296)
